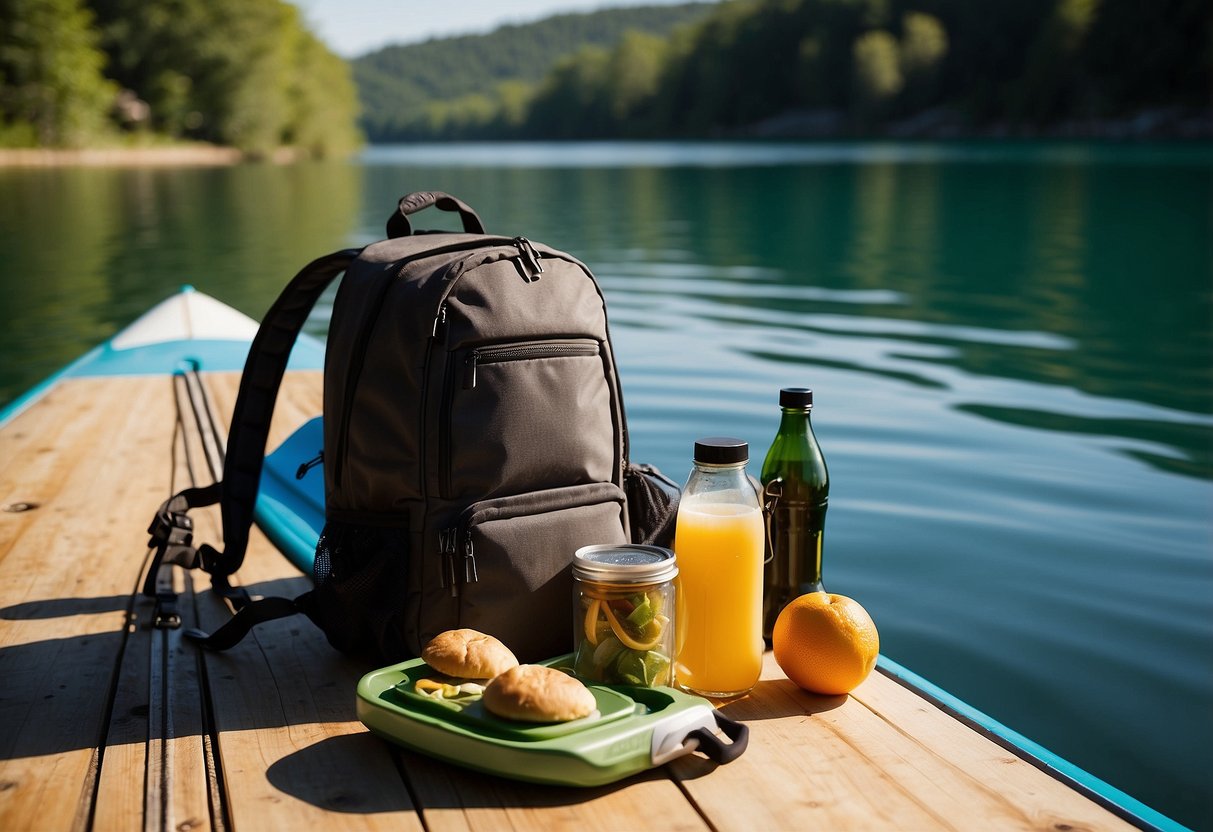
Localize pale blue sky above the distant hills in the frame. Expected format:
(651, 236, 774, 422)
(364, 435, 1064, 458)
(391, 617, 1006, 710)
(291, 0, 713, 58)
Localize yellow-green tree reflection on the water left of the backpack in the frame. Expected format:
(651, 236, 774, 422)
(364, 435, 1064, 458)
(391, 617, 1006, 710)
(0, 163, 361, 401)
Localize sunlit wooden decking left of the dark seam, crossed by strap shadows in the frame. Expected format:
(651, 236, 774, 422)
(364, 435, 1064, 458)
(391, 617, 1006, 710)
(0, 378, 180, 830)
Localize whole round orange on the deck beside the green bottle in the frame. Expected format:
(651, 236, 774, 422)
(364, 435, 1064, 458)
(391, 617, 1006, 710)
(770, 592, 881, 695)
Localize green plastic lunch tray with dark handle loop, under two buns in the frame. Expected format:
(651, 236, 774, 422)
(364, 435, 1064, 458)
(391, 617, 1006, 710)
(358, 656, 748, 786)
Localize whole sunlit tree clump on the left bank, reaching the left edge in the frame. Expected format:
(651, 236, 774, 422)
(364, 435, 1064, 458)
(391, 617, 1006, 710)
(0, 0, 361, 156)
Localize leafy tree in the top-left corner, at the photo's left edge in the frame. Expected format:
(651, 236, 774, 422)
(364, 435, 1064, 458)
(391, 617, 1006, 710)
(0, 0, 118, 147)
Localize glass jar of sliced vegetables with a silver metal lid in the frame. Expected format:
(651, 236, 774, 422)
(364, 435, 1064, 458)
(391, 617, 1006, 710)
(573, 543, 678, 686)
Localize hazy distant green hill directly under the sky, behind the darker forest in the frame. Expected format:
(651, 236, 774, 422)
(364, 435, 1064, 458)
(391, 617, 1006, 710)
(352, 2, 714, 142)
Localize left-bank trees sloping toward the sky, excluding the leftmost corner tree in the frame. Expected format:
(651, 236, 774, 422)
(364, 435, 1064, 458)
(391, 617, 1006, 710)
(93, 0, 358, 156)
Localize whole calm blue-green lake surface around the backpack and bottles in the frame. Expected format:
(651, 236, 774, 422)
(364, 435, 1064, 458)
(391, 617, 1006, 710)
(0, 143, 1213, 828)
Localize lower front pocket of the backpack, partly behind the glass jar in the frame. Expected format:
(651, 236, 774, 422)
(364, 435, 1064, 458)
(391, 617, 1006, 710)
(442, 483, 627, 662)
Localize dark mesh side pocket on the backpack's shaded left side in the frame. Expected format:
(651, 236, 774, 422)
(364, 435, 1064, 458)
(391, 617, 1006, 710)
(313, 522, 409, 661)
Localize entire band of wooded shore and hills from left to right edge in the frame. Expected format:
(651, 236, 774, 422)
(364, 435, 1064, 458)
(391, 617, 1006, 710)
(0, 0, 1213, 156)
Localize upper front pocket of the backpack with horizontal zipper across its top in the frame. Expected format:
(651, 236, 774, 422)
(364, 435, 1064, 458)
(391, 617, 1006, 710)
(438, 338, 616, 498)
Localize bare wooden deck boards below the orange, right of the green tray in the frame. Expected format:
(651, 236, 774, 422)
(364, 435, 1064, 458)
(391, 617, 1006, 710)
(673, 654, 1131, 830)
